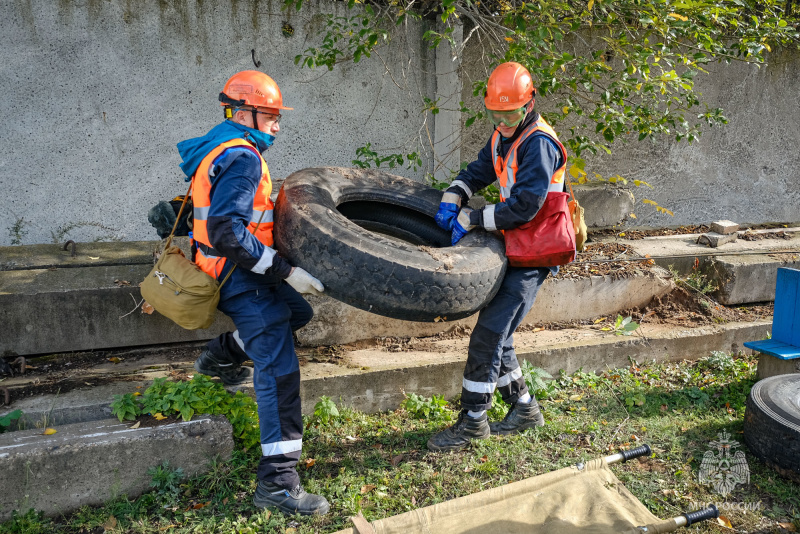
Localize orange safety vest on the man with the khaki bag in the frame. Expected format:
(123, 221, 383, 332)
(192, 139, 275, 278)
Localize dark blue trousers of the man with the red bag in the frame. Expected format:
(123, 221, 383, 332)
(461, 267, 550, 411)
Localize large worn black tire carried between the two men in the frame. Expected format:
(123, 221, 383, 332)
(274, 167, 506, 321)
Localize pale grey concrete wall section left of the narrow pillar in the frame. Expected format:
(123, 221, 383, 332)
(0, 0, 450, 245)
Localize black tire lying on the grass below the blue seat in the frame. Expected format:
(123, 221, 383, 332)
(744, 373, 800, 481)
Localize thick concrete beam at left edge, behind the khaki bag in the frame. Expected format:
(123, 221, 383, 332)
(0, 265, 233, 355)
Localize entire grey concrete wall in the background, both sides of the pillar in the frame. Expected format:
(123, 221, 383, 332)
(0, 0, 800, 246)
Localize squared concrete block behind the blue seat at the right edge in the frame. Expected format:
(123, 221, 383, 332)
(709, 255, 800, 305)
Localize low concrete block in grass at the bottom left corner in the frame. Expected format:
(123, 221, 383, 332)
(0, 416, 233, 521)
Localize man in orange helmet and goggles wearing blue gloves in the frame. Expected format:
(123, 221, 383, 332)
(428, 62, 567, 451)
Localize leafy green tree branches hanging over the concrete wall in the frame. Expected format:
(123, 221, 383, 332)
(284, 0, 800, 213)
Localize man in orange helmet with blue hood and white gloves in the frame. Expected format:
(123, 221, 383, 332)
(178, 71, 329, 515)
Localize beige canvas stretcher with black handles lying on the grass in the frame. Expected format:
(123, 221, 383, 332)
(336, 445, 719, 534)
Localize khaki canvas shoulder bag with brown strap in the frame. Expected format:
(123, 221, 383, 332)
(140, 185, 234, 330)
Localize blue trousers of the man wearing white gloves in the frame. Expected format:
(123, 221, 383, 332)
(219, 283, 312, 489)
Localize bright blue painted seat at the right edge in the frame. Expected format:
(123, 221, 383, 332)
(744, 267, 800, 360)
